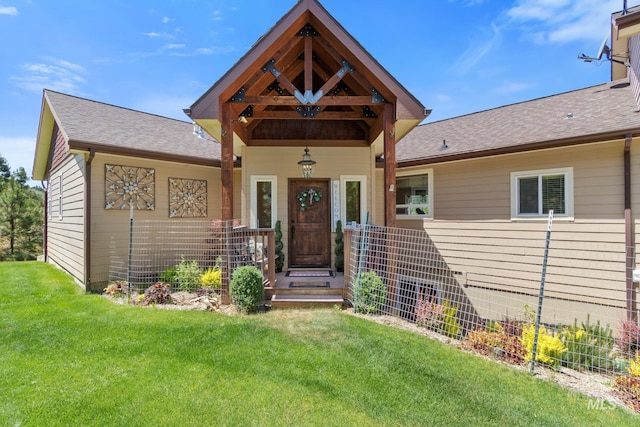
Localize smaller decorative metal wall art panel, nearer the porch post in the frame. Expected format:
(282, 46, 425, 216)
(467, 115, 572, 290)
(169, 178, 207, 218)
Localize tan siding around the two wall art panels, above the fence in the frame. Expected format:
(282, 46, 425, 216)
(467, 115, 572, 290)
(91, 154, 221, 290)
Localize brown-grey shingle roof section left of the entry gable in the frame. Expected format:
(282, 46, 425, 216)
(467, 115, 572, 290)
(45, 90, 220, 164)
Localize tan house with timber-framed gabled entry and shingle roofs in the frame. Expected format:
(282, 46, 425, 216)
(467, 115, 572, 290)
(33, 0, 640, 317)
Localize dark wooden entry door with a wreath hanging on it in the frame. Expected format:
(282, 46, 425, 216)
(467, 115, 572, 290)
(289, 178, 331, 267)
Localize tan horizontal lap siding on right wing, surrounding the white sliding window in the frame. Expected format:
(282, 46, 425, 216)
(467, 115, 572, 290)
(399, 142, 628, 308)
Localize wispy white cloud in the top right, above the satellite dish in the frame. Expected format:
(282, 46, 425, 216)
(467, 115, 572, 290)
(506, 0, 638, 44)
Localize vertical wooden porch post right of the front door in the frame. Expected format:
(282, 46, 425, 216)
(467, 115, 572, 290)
(383, 104, 396, 227)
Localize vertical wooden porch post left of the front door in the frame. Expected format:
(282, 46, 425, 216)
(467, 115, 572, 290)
(220, 102, 234, 221)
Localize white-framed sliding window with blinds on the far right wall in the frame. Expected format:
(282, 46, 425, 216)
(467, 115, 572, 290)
(511, 167, 573, 219)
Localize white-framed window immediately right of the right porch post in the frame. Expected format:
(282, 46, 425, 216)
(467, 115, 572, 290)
(395, 169, 433, 218)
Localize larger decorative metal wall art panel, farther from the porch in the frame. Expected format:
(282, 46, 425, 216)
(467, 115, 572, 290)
(104, 164, 155, 210)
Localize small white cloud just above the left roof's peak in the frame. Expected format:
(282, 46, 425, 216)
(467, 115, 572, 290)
(11, 57, 86, 94)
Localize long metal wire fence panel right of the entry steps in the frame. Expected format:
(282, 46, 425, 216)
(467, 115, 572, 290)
(345, 224, 640, 382)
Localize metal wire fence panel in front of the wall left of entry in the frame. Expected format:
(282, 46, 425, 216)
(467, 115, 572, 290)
(109, 220, 273, 295)
